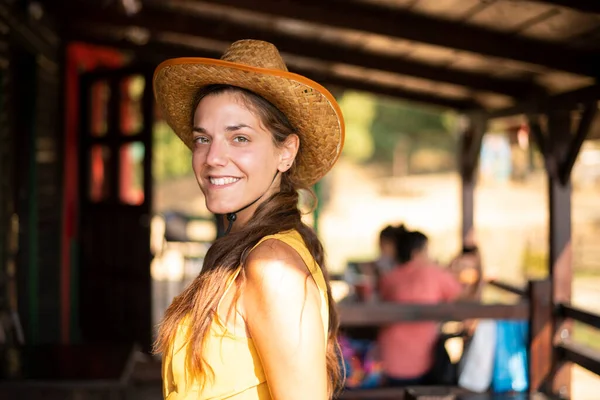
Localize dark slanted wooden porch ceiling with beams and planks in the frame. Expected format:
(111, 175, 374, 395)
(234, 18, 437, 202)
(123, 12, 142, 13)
(59, 0, 600, 115)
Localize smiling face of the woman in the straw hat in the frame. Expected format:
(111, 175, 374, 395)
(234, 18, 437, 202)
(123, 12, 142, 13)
(192, 92, 298, 214)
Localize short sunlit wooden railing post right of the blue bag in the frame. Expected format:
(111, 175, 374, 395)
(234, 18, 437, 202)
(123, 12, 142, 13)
(528, 280, 553, 394)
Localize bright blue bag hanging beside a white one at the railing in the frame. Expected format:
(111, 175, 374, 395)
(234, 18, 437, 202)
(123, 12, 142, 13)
(492, 321, 529, 393)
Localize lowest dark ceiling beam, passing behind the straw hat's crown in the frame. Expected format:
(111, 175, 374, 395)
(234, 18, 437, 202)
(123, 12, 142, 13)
(69, 27, 480, 110)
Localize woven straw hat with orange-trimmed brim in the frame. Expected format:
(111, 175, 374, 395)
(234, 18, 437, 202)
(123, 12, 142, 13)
(154, 40, 344, 185)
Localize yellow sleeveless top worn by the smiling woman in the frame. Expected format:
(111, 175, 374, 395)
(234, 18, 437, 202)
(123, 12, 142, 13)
(162, 230, 329, 400)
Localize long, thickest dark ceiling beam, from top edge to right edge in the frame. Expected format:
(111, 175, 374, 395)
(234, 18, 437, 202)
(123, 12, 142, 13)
(191, 0, 600, 76)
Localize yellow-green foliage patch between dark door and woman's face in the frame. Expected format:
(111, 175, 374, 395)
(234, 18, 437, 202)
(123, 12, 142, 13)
(153, 121, 193, 183)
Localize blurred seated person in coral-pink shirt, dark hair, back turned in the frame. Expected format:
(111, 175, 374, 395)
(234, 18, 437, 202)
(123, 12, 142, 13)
(378, 226, 462, 386)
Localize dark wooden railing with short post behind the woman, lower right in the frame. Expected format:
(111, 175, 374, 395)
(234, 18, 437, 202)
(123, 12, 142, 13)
(339, 280, 600, 399)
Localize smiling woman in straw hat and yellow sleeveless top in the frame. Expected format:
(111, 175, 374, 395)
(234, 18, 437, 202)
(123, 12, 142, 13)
(154, 40, 344, 400)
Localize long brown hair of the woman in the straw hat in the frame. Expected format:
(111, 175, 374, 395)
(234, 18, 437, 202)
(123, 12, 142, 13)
(155, 85, 341, 397)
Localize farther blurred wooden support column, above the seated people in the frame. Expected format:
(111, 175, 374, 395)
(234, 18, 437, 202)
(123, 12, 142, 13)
(459, 113, 487, 246)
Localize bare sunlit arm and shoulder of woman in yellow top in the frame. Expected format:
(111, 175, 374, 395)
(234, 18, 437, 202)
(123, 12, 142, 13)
(242, 240, 327, 400)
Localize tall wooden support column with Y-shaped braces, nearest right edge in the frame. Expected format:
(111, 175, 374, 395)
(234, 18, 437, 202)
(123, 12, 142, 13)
(529, 101, 598, 398)
